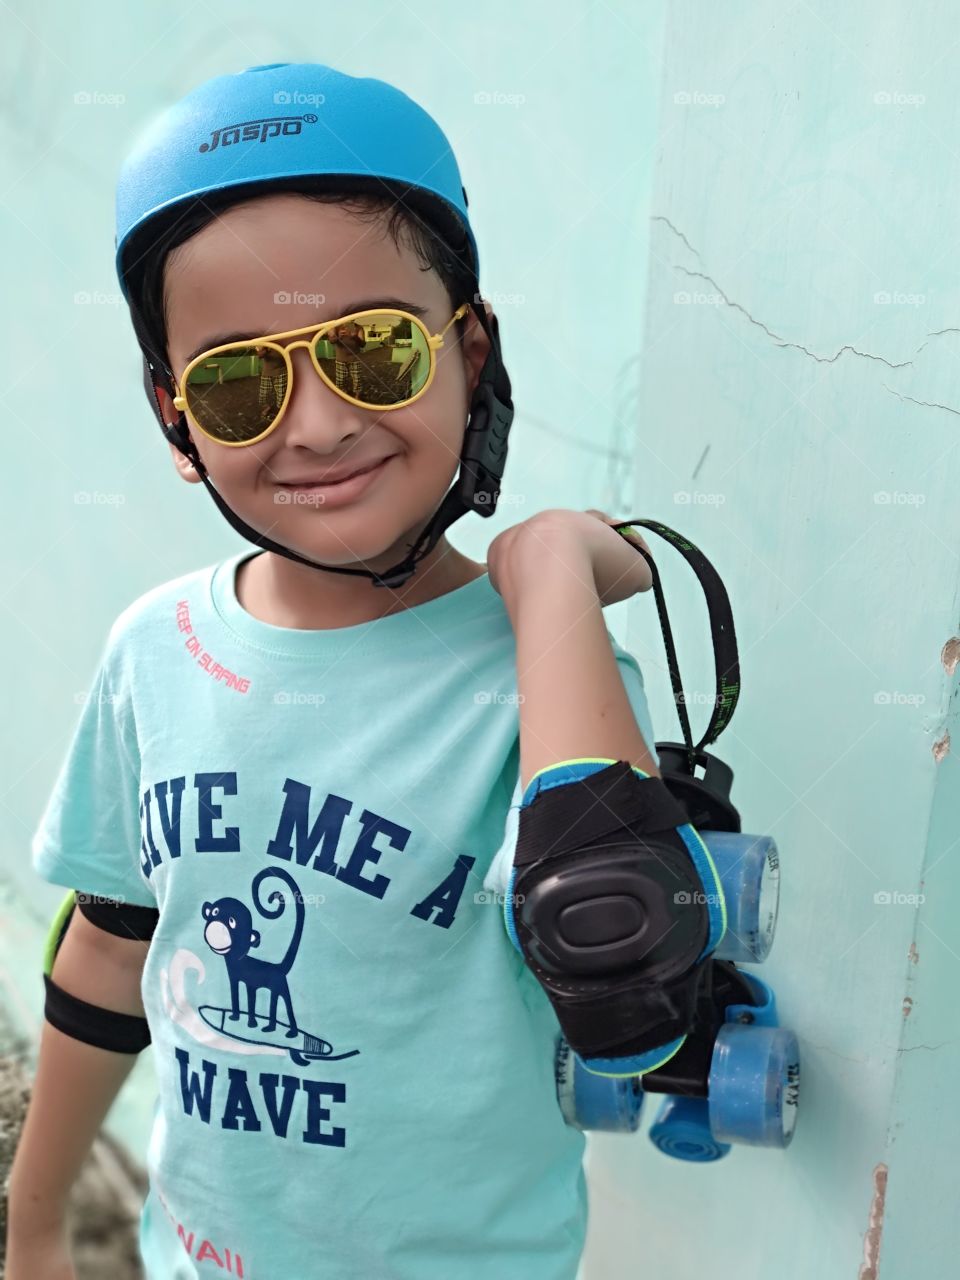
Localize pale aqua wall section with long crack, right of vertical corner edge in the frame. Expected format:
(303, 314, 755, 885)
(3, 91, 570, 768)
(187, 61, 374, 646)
(593, 3, 960, 1280)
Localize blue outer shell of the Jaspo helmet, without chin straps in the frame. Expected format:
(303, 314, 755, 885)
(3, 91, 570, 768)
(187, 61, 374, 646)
(115, 63, 479, 298)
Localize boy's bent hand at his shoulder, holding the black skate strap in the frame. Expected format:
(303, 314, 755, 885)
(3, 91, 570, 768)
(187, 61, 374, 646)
(486, 507, 653, 607)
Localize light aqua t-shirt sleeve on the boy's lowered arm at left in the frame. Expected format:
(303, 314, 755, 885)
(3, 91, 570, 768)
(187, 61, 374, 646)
(31, 631, 156, 908)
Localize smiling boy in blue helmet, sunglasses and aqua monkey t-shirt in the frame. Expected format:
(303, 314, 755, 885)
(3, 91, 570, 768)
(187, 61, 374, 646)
(10, 64, 657, 1280)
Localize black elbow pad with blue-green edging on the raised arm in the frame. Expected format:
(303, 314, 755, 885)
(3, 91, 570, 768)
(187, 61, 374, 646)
(504, 760, 726, 1075)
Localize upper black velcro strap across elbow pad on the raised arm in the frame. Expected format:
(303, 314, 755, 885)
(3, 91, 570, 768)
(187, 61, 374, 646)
(513, 760, 689, 867)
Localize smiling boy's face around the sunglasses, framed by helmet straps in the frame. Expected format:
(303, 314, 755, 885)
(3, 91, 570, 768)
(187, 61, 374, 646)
(161, 195, 489, 568)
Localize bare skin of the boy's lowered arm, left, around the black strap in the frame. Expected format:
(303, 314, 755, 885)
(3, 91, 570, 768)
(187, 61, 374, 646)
(9, 919, 143, 1239)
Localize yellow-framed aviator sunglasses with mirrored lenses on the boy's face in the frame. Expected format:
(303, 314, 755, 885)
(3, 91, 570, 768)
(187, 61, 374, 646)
(173, 302, 470, 448)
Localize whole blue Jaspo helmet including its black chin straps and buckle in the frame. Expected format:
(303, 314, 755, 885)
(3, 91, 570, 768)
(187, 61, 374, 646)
(115, 63, 513, 586)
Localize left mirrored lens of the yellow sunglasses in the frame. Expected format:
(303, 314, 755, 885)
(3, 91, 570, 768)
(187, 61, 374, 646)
(187, 346, 287, 444)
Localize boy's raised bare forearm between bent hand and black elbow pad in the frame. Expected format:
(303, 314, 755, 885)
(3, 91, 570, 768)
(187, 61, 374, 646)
(503, 538, 659, 790)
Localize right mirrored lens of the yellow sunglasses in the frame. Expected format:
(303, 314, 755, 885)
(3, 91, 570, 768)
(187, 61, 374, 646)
(315, 311, 430, 406)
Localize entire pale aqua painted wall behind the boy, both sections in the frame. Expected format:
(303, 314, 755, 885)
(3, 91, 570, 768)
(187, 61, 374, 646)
(0, 0, 960, 1280)
